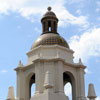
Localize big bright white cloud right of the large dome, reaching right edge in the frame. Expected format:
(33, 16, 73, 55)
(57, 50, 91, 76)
(70, 28, 100, 62)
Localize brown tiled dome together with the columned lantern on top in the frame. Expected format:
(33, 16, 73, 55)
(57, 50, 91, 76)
(31, 7, 69, 49)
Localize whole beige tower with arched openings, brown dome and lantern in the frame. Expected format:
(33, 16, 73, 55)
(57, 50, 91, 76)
(7, 7, 96, 100)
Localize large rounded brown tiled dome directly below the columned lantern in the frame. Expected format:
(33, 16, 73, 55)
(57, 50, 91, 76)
(31, 33, 69, 49)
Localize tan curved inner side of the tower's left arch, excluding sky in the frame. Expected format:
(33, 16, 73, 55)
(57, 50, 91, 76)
(25, 72, 36, 100)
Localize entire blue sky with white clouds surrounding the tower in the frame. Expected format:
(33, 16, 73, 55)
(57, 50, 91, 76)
(0, 0, 100, 100)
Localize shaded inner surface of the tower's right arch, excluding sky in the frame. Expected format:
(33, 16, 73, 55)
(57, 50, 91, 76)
(63, 71, 76, 100)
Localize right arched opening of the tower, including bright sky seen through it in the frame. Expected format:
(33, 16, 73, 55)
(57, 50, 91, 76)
(63, 72, 76, 100)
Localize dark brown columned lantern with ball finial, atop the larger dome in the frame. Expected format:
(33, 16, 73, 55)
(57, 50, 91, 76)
(41, 7, 58, 34)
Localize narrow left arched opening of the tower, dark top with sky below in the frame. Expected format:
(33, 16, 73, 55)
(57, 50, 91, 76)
(29, 74, 35, 98)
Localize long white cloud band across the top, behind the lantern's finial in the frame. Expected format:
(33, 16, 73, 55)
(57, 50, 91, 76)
(0, 0, 89, 28)
